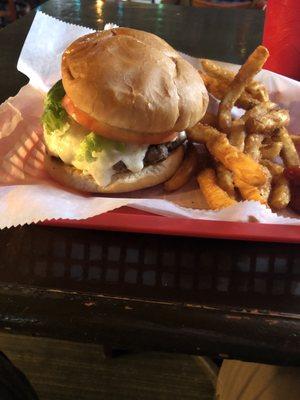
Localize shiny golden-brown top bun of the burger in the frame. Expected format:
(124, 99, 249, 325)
(62, 28, 208, 133)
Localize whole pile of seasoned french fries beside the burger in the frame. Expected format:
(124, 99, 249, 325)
(165, 46, 300, 210)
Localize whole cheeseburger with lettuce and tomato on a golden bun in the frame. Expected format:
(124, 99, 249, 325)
(42, 28, 208, 193)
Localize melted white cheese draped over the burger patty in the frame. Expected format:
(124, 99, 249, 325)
(45, 122, 148, 186)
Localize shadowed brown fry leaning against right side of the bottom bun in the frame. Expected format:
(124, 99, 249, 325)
(164, 143, 199, 192)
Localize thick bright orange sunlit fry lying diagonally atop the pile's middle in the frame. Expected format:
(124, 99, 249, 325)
(206, 134, 266, 186)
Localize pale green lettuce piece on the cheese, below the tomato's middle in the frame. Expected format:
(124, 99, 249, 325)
(76, 132, 125, 162)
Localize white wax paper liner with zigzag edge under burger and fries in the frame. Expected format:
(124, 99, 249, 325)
(0, 12, 300, 228)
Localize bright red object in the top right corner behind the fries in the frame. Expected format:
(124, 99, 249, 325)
(263, 0, 300, 80)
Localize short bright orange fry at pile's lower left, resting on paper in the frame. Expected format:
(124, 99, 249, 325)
(197, 168, 236, 210)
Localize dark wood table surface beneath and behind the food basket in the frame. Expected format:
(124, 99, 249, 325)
(0, 0, 300, 365)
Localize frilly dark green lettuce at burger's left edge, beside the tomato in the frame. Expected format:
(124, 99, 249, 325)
(42, 80, 68, 133)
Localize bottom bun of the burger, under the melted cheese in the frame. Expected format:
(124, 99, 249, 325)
(45, 146, 184, 193)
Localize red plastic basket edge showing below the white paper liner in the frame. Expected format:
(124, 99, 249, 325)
(43, 207, 300, 243)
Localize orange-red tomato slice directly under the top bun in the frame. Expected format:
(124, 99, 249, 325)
(62, 95, 178, 144)
